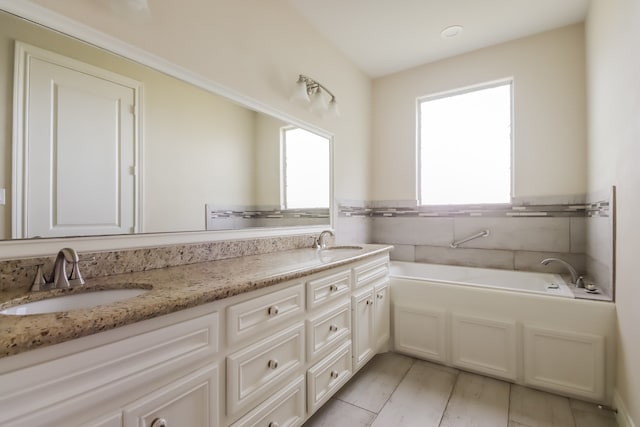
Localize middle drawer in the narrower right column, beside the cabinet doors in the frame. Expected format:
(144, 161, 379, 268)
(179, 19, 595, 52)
(307, 300, 351, 361)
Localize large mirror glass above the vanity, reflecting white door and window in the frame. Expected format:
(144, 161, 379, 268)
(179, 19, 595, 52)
(0, 11, 331, 239)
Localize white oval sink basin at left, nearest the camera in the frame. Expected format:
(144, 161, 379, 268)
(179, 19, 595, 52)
(0, 289, 148, 316)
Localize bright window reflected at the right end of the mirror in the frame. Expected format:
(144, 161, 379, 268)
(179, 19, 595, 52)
(282, 128, 331, 209)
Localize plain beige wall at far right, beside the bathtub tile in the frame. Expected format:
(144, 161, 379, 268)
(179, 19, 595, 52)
(586, 0, 640, 425)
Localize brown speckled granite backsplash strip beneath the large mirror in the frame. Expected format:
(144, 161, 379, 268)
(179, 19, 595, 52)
(0, 234, 314, 291)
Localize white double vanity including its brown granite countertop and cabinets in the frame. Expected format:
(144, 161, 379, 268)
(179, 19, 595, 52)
(0, 245, 390, 427)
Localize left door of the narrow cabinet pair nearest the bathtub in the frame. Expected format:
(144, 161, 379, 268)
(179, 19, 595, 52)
(351, 287, 375, 372)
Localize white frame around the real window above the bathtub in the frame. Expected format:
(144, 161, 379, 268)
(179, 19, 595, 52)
(416, 77, 515, 207)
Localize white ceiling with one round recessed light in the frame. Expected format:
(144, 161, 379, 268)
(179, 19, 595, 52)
(288, 0, 590, 78)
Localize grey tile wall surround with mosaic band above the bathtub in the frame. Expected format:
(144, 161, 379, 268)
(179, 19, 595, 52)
(338, 192, 614, 297)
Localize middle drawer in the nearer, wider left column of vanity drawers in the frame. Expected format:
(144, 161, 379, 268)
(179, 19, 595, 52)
(227, 323, 304, 414)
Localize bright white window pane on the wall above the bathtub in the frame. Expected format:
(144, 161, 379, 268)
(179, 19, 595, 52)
(418, 82, 512, 205)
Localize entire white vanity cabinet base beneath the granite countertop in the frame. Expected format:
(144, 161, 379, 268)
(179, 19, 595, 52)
(0, 249, 396, 427)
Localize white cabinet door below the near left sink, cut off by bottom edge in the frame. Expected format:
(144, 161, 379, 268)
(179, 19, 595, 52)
(123, 365, 218, 427)
